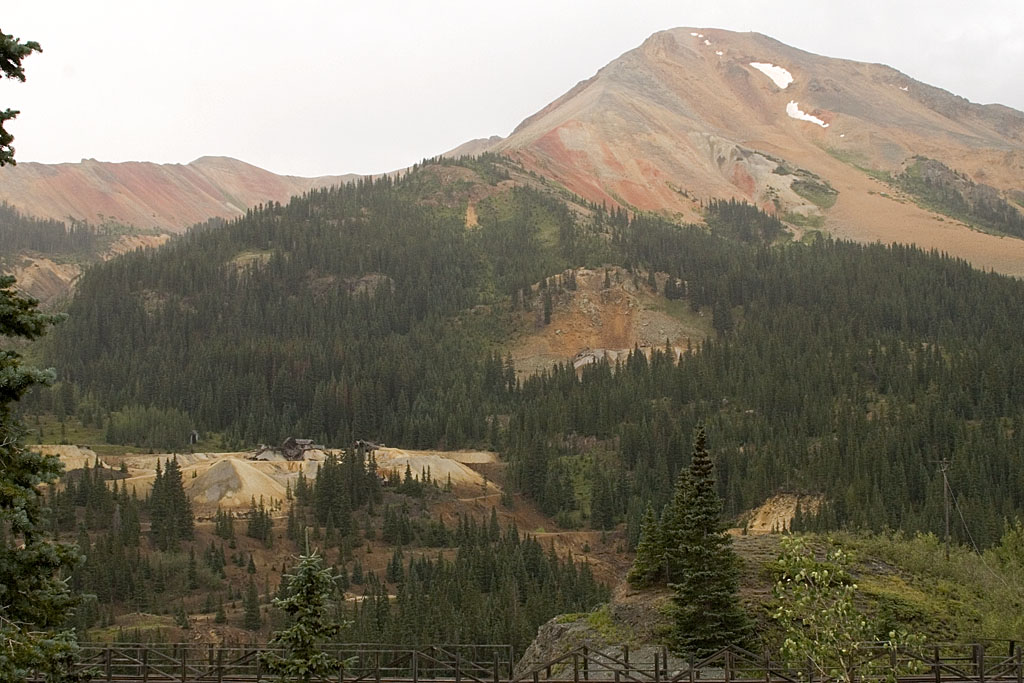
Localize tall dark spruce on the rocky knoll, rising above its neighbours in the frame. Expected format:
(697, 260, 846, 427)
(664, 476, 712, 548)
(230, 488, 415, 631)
(663, 427, 750, 656)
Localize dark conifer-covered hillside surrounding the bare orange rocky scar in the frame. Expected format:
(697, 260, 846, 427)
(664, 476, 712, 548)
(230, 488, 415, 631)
(39, 160, 1024, 544)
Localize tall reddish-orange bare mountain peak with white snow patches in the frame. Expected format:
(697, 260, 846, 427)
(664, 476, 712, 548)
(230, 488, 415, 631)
(473, 29, 1024, 274)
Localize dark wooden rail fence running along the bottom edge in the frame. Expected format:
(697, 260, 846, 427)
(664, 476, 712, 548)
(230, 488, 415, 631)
(37, 641, 1024, 683)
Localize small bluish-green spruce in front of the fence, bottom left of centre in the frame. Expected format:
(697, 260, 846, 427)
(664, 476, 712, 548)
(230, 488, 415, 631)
(263, 551, 345, 683)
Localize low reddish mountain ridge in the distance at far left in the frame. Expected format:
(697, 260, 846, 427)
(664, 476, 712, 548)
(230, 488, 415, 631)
(0, 157, 357, 232)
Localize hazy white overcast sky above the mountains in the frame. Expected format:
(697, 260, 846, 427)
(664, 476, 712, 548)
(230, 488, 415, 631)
(6, 0, 1024, 175)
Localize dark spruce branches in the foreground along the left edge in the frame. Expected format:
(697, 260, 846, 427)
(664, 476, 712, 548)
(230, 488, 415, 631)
(0, 274, 80, 681)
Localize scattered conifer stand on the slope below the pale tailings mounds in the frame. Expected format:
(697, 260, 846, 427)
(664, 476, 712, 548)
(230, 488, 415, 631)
(48, 450, 608, 651)
